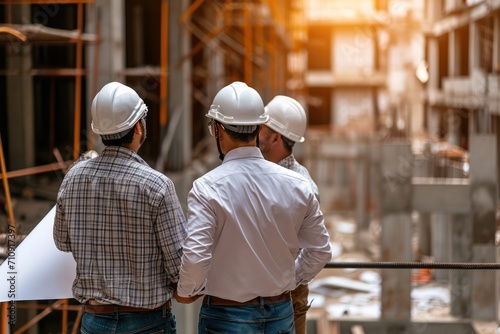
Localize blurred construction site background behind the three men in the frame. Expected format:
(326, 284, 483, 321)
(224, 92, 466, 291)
(0, 0, 500, 334)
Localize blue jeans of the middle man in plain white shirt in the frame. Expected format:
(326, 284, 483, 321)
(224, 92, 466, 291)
(198, 300, 295, 334)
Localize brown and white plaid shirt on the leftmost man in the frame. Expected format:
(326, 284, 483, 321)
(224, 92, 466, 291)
(54, 146, 186, 308)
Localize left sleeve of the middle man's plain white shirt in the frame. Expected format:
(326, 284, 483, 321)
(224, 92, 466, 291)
(177, 182, 216, 297)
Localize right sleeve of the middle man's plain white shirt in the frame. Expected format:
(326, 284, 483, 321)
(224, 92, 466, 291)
(295, 194, 332, 285)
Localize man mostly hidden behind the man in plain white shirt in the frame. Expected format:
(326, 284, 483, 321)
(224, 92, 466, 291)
(259, 95, 319, 334)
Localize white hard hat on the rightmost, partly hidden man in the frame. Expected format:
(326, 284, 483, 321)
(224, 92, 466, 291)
(265, 95, 307, 143)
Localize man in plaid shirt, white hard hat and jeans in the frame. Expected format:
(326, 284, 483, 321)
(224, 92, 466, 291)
(54, 82, 186, 333)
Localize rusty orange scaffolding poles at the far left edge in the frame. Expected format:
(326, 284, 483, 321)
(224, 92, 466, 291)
(0, 0, 99, 334)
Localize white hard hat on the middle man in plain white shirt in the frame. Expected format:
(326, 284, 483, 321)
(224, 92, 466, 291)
(205, 81, 269, 133)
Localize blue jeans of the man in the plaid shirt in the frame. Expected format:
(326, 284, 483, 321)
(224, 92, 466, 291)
(81, 309, 176, 334)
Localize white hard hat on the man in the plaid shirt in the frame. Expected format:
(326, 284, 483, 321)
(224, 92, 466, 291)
(91, 82, 148, 139)
